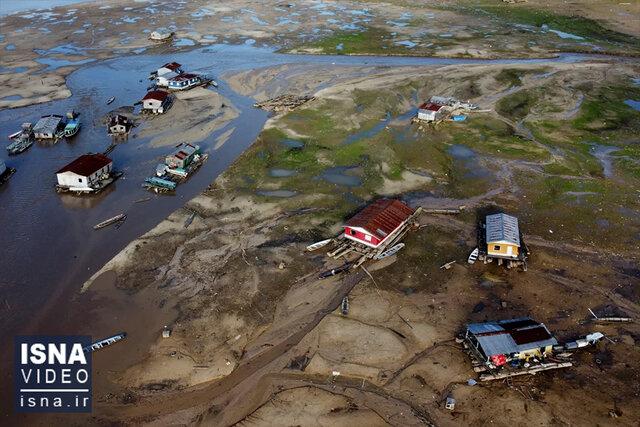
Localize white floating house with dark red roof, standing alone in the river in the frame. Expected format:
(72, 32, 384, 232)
(56, 154, 113, 191)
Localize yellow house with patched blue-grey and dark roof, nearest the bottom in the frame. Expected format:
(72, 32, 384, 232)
(464, 317, 558, 367)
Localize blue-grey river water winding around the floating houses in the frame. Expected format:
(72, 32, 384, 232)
(0, 45, 596, 346)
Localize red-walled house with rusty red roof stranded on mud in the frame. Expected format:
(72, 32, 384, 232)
(344, 199, 414, 248)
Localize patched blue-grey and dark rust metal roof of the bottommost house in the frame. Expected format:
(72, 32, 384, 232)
(467, 317, 558, 357)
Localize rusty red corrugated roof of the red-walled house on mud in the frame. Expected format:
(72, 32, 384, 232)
(346, 199, 413, 239)
